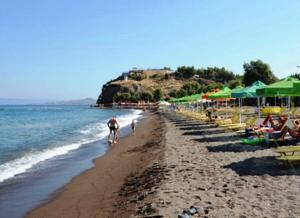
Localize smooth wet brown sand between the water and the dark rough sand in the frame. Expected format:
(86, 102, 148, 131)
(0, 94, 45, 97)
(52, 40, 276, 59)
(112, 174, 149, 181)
(26, 112, 164, 217)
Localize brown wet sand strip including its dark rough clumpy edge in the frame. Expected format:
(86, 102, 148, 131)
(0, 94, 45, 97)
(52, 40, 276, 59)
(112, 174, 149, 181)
(28, 113, 165, 218)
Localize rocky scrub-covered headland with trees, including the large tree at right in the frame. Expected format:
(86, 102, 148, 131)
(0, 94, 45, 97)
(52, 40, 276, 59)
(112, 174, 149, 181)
(97, 60, 278, 104)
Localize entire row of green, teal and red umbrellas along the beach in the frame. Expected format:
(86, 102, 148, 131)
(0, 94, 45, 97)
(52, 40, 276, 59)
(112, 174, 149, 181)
(169, 77, 300, 103)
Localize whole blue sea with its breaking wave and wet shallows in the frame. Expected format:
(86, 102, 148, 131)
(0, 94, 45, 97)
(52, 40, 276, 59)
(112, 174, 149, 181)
(0, 105, 142, 218)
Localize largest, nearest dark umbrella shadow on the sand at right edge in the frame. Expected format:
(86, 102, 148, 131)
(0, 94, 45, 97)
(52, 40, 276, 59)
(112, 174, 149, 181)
(224, 156, 300, 176)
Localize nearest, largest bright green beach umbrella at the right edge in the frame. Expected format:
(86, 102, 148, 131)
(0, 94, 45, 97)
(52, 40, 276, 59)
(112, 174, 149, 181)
(256, 77, 300, 97)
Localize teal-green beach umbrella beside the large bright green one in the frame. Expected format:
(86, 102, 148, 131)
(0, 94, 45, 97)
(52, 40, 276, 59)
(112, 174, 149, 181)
(231, 81, 266, 98)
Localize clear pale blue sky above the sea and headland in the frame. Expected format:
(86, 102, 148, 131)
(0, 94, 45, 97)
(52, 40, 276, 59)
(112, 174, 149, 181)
(0, 0, 300, 99)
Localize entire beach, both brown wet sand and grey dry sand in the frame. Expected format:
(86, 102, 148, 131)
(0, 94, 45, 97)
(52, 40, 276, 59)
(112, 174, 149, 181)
(28, 113, 300, 217)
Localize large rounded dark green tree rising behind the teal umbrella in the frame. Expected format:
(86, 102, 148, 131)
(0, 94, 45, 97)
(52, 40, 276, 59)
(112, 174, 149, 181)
(243, 60, 278, 86)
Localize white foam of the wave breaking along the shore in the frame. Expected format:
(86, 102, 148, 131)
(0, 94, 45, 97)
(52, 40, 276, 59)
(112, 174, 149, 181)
(0, 110, 141, 182)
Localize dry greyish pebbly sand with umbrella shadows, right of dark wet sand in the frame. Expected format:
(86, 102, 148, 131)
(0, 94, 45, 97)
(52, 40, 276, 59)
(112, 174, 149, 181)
(155, 115, 300, 217)
